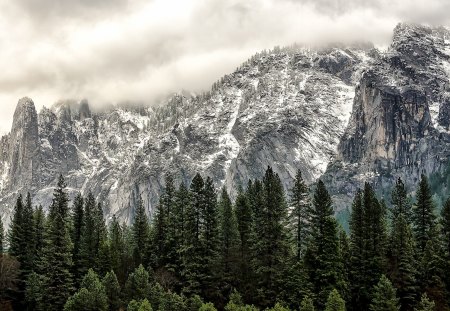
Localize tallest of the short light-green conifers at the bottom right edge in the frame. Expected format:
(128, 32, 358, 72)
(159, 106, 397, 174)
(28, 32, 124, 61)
(370, 274, 400, 311)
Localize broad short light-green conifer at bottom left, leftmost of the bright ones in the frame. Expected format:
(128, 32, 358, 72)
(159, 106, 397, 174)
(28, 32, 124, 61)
(64, 269, 108, 311)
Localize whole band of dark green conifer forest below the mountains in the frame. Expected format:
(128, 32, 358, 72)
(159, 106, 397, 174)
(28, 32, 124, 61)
(0, 167, 450, 311)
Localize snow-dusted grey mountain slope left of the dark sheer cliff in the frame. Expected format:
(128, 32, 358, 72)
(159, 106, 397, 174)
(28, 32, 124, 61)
(0, 45, 378, 227)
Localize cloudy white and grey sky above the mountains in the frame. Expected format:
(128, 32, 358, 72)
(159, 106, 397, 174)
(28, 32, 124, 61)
(0, 0, 450, 133)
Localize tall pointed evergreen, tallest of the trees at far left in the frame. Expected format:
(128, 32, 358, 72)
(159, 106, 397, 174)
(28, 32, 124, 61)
(42, 175, 73, 311)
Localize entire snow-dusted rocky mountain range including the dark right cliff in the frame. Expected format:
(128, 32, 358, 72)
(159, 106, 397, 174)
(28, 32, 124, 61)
(0, 24, 450, 227)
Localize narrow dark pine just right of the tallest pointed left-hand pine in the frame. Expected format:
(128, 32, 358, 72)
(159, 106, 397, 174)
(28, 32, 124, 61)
(71, 193, 84, 286)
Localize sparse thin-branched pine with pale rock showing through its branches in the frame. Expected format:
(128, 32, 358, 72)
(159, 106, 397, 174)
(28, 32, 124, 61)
(289, 171, 311, 260)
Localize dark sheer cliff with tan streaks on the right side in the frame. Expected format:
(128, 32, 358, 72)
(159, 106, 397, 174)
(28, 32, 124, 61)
(322, 24, 450, 208)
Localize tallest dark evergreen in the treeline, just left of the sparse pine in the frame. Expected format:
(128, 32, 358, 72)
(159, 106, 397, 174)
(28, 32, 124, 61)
(253, 167, 290, 306)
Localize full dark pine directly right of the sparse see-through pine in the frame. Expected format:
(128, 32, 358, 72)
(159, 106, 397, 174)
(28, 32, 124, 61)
(305, 180, 340, 306)
